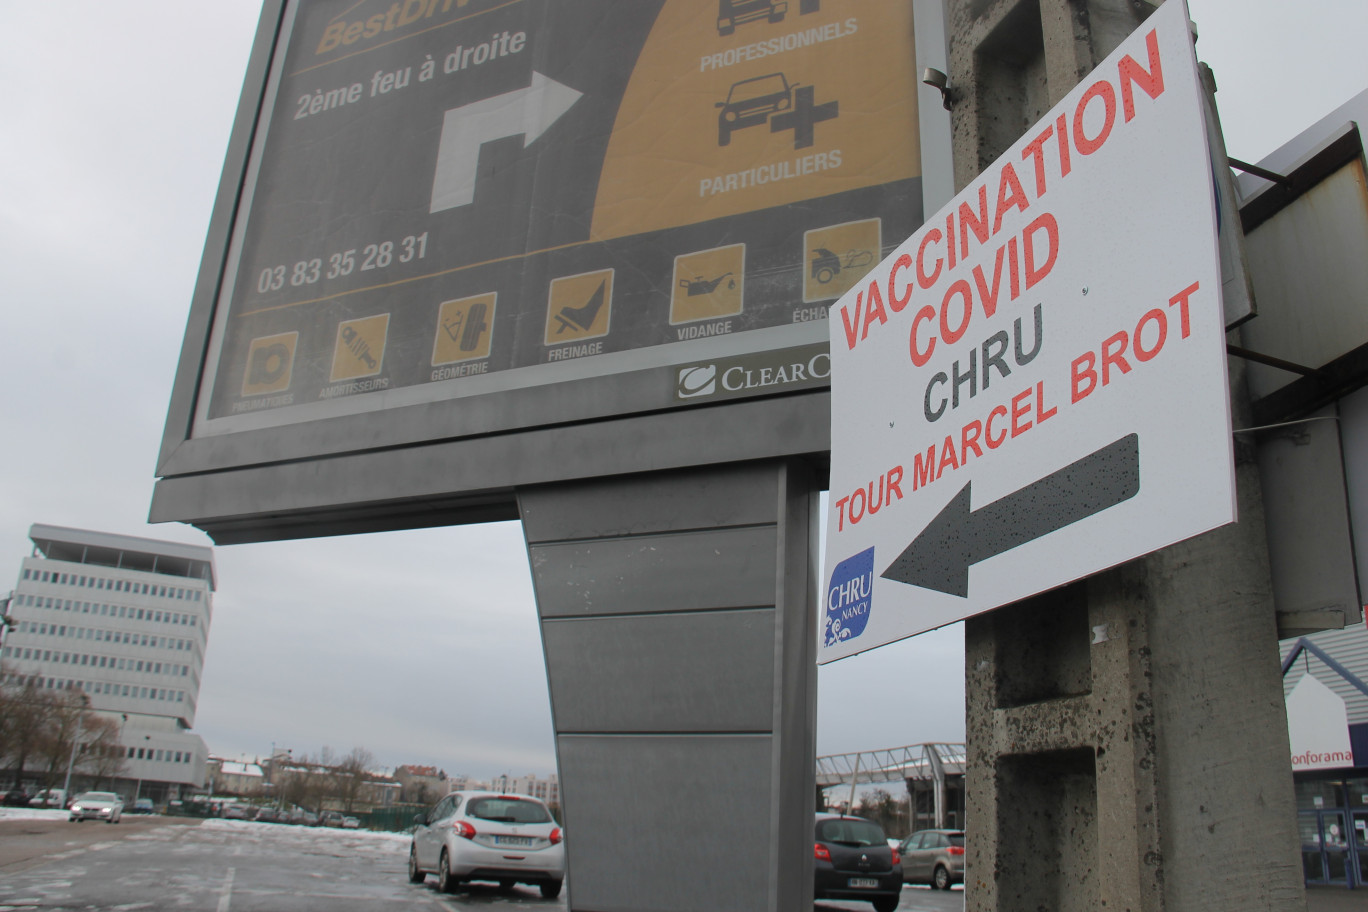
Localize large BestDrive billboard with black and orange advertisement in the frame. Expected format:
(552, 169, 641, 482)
(153, 0, 921, 535)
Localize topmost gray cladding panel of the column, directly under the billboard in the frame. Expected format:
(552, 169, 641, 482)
(521, 465, 778, 543)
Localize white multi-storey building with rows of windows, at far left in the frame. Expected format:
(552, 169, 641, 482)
(0, 524, 215, 800)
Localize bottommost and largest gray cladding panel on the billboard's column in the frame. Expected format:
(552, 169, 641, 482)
(557, 736, 771, 912)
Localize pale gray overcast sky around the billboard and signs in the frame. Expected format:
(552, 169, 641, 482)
(0, 0, 1368, 777)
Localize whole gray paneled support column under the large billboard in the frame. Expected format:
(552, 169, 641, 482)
(518, 459, 818, 912)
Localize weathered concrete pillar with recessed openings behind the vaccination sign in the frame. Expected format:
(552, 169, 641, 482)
(949, 0, 1305, 912)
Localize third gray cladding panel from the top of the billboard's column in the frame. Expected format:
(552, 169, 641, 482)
(542, 608, 776, 733)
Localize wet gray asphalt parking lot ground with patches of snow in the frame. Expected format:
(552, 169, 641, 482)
(0, 815, 963, 912)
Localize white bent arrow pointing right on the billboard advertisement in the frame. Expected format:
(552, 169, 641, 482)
(428, 70, 584, 212)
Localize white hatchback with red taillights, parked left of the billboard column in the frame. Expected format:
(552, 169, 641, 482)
(409, 792, 565, 900)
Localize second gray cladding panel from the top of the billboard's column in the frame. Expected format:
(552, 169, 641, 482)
(528, 526, 777, 618)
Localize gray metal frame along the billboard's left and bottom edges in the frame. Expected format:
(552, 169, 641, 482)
(150, 0, 941, 543)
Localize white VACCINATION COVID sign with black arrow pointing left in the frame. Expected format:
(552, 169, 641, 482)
(819, 0, 1235, 662)
